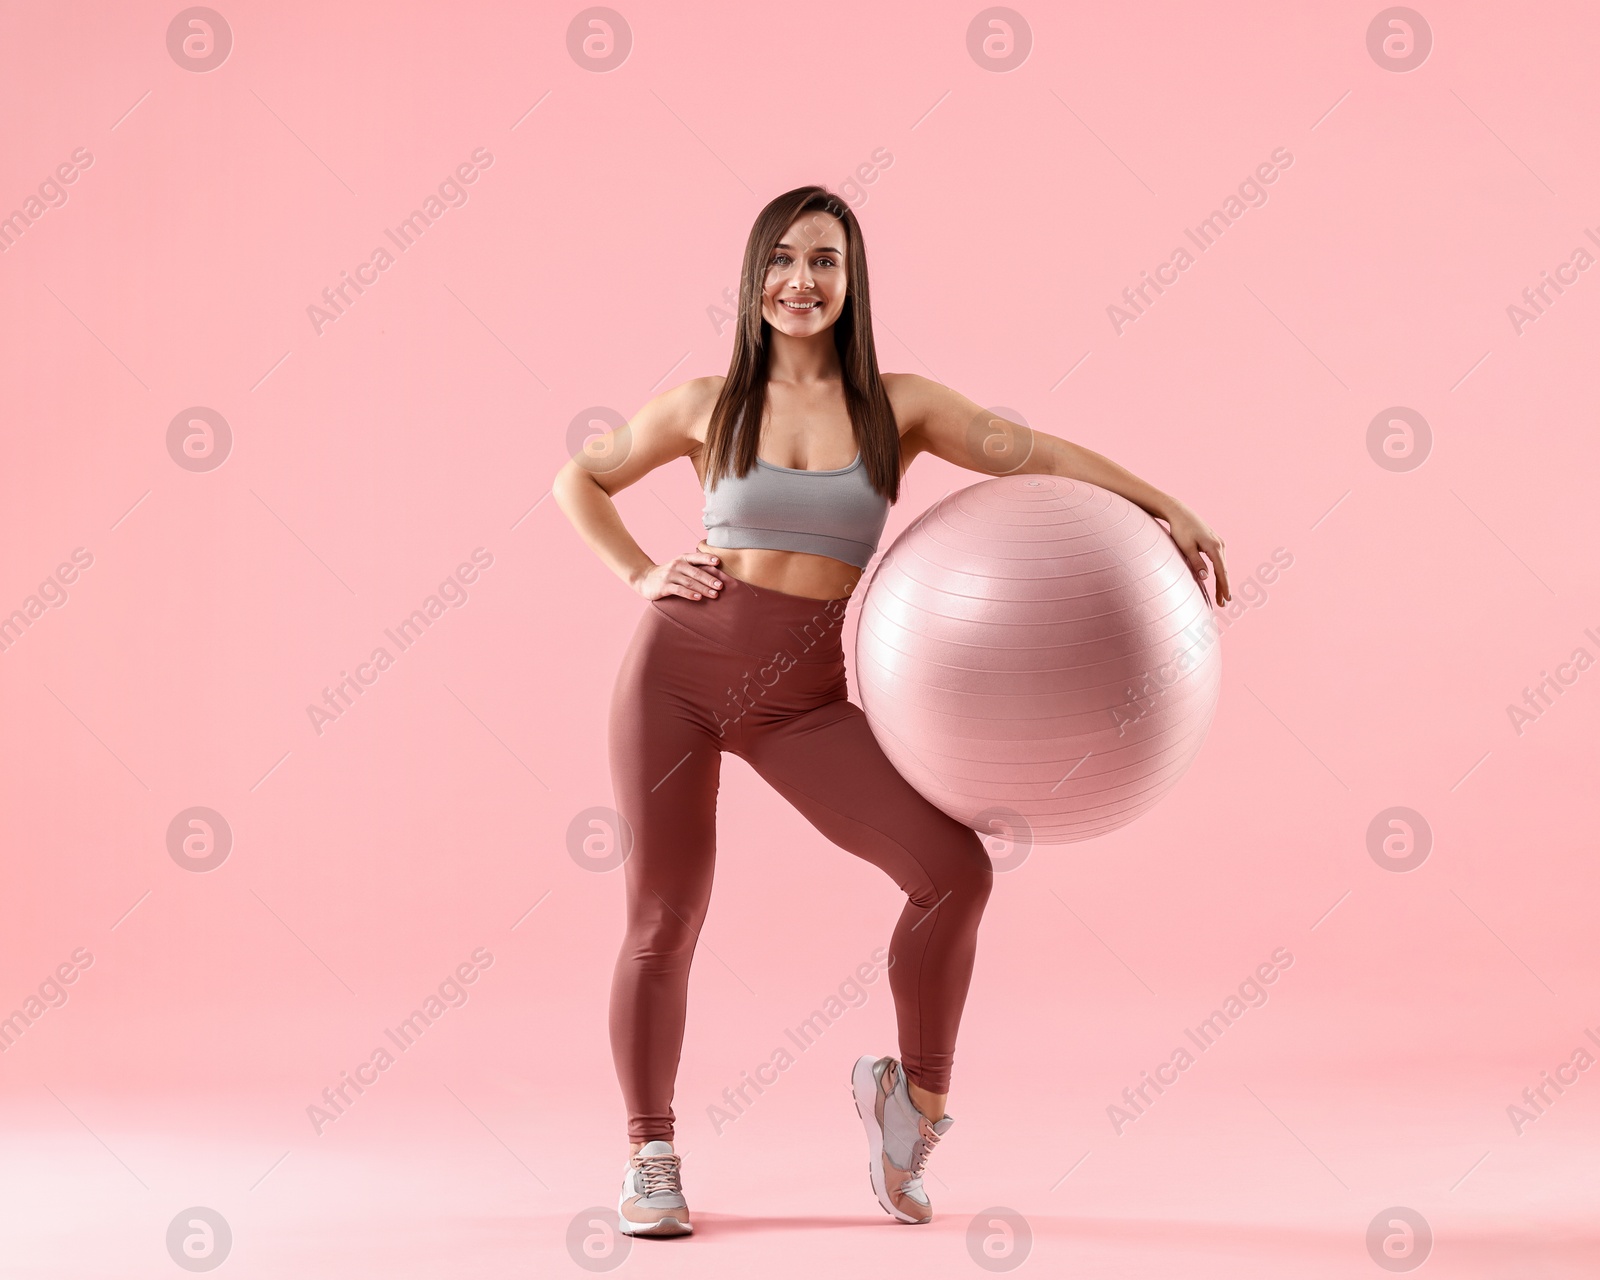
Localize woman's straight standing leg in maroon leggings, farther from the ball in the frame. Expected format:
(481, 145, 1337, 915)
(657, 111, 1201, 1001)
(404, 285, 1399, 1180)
(610, 608, 722, 1150)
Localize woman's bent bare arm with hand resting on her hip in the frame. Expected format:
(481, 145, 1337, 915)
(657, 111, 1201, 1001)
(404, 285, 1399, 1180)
(550, 378, 722, 600)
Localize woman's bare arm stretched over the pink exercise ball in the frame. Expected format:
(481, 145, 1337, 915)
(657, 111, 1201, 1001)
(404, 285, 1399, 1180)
(896, 374, 1232, 605)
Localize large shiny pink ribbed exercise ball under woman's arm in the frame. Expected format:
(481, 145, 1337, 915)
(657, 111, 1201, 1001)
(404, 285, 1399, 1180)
(856, 475, 1222, 845)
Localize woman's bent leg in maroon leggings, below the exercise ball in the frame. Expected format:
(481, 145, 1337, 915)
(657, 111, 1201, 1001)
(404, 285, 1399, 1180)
(739, 694, 994, 1120)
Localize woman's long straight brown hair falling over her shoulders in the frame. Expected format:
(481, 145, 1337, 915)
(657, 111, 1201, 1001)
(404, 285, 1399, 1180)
(706, 186, 901, 502)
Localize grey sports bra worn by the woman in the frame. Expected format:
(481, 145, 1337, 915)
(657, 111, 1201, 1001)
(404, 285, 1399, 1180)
(701, 450, 890, 570)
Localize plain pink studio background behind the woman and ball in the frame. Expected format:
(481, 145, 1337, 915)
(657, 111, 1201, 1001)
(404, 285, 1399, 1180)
(0, 0, 1600, 1277)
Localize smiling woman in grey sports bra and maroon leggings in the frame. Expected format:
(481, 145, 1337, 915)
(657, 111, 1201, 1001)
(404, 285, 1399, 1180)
(554, 187, 1229, 1235)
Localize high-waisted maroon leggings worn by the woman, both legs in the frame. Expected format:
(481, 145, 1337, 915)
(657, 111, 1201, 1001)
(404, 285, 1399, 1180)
(610, 573, 994, 1142)
